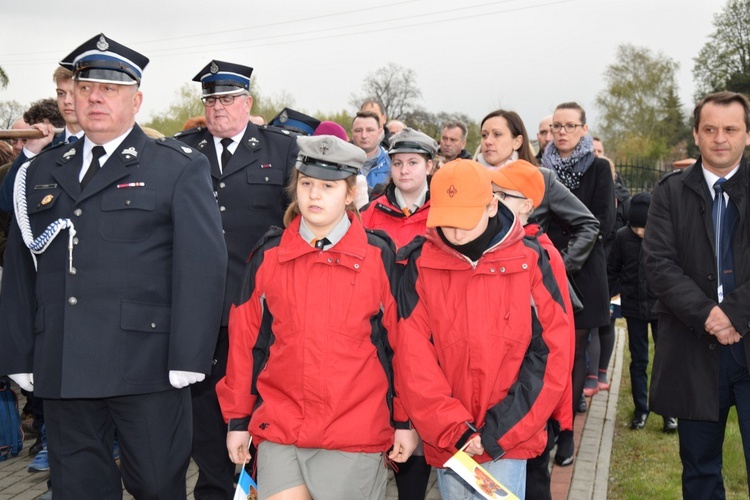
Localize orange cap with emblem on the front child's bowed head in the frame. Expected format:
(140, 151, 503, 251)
(427, 159, 492, 229)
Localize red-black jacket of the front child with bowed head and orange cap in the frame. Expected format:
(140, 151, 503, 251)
(394, 204, 570, 467)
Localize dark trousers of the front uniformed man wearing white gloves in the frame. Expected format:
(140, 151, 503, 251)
(44, 388, 193, 500)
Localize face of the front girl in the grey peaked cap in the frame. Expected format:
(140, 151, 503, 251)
(297, 174, 354, 237)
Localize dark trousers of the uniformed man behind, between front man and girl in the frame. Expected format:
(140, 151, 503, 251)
(191, 327, 235, 500)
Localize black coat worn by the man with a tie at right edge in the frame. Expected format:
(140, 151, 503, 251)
(643, 159, 750, 422)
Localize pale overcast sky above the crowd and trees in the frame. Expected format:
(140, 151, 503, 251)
(0, 0, 724, 138)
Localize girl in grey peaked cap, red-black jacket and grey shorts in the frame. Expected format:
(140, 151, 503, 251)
(216, 136, 417, 499)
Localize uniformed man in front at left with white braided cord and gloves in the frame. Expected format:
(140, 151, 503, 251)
(0, 34, 226, 499)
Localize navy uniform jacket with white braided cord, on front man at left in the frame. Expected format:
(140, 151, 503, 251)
(0, 125, 226, 398)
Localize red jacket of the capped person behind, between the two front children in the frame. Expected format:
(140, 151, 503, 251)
(362, 184, 430, 248)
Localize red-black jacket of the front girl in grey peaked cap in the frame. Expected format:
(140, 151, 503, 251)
(216, 213, 406, 452)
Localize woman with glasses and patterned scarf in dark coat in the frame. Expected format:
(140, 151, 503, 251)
(542, 102, 615, 465)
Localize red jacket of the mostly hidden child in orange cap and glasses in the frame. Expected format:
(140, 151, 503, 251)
(523, 224, 576, 431)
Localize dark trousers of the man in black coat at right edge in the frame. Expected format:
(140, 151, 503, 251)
(678, 346, 750, 500)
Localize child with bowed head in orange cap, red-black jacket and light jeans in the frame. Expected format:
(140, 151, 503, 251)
(394, 160, 570, 498)
